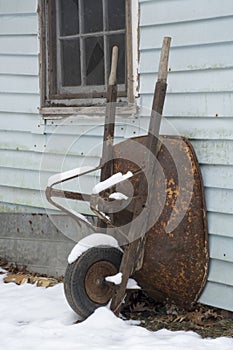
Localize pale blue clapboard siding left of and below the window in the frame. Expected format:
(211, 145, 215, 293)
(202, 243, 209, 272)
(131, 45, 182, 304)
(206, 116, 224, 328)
(0, 0, 139, 213)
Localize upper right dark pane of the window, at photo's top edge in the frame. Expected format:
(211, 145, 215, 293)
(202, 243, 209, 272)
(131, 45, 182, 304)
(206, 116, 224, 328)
(107, 0, 125, 30)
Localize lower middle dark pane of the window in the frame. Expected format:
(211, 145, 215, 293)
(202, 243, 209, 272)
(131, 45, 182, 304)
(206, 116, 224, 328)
(85, 37, 104, 85)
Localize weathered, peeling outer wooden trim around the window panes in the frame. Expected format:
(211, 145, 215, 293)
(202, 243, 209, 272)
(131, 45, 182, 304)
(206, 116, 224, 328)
(38, 0, 135, 118)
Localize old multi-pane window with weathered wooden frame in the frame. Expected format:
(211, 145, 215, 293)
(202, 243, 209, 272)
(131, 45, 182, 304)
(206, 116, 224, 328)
(41, 0, 132, 106)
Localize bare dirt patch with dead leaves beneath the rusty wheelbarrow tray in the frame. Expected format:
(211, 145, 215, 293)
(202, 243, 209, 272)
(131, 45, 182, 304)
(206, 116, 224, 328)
(122, 291, 233, 338)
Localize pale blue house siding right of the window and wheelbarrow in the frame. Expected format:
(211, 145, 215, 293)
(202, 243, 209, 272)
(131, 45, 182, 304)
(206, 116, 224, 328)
(139, 0, 233, 311)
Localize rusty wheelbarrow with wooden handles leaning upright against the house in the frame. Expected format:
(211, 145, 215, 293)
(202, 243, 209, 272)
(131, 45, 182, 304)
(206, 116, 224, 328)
(46, 37, 209, 318)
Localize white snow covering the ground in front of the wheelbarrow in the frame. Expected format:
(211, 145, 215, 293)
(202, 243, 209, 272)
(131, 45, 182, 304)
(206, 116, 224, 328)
(0, 275, 233, 350)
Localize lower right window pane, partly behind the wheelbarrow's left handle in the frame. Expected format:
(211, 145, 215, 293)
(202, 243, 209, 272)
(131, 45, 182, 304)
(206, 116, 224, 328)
(108, 34, 126, 84)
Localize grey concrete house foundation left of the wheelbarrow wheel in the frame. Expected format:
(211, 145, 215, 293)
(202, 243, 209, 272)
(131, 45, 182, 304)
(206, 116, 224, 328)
(0, 213, 95, 276)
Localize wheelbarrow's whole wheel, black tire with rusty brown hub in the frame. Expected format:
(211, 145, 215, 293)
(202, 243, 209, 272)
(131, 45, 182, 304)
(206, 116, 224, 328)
(64, 246, 122, 318)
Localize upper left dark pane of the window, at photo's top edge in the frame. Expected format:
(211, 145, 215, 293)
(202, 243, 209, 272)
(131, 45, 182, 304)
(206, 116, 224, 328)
(60, 0, 79, 36)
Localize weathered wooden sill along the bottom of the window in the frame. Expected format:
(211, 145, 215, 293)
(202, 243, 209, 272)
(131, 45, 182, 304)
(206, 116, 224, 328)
(40, 103, 137, 120)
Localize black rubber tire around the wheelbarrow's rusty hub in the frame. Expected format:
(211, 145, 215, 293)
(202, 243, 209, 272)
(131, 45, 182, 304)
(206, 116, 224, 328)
(64, 246, 122, 319)
